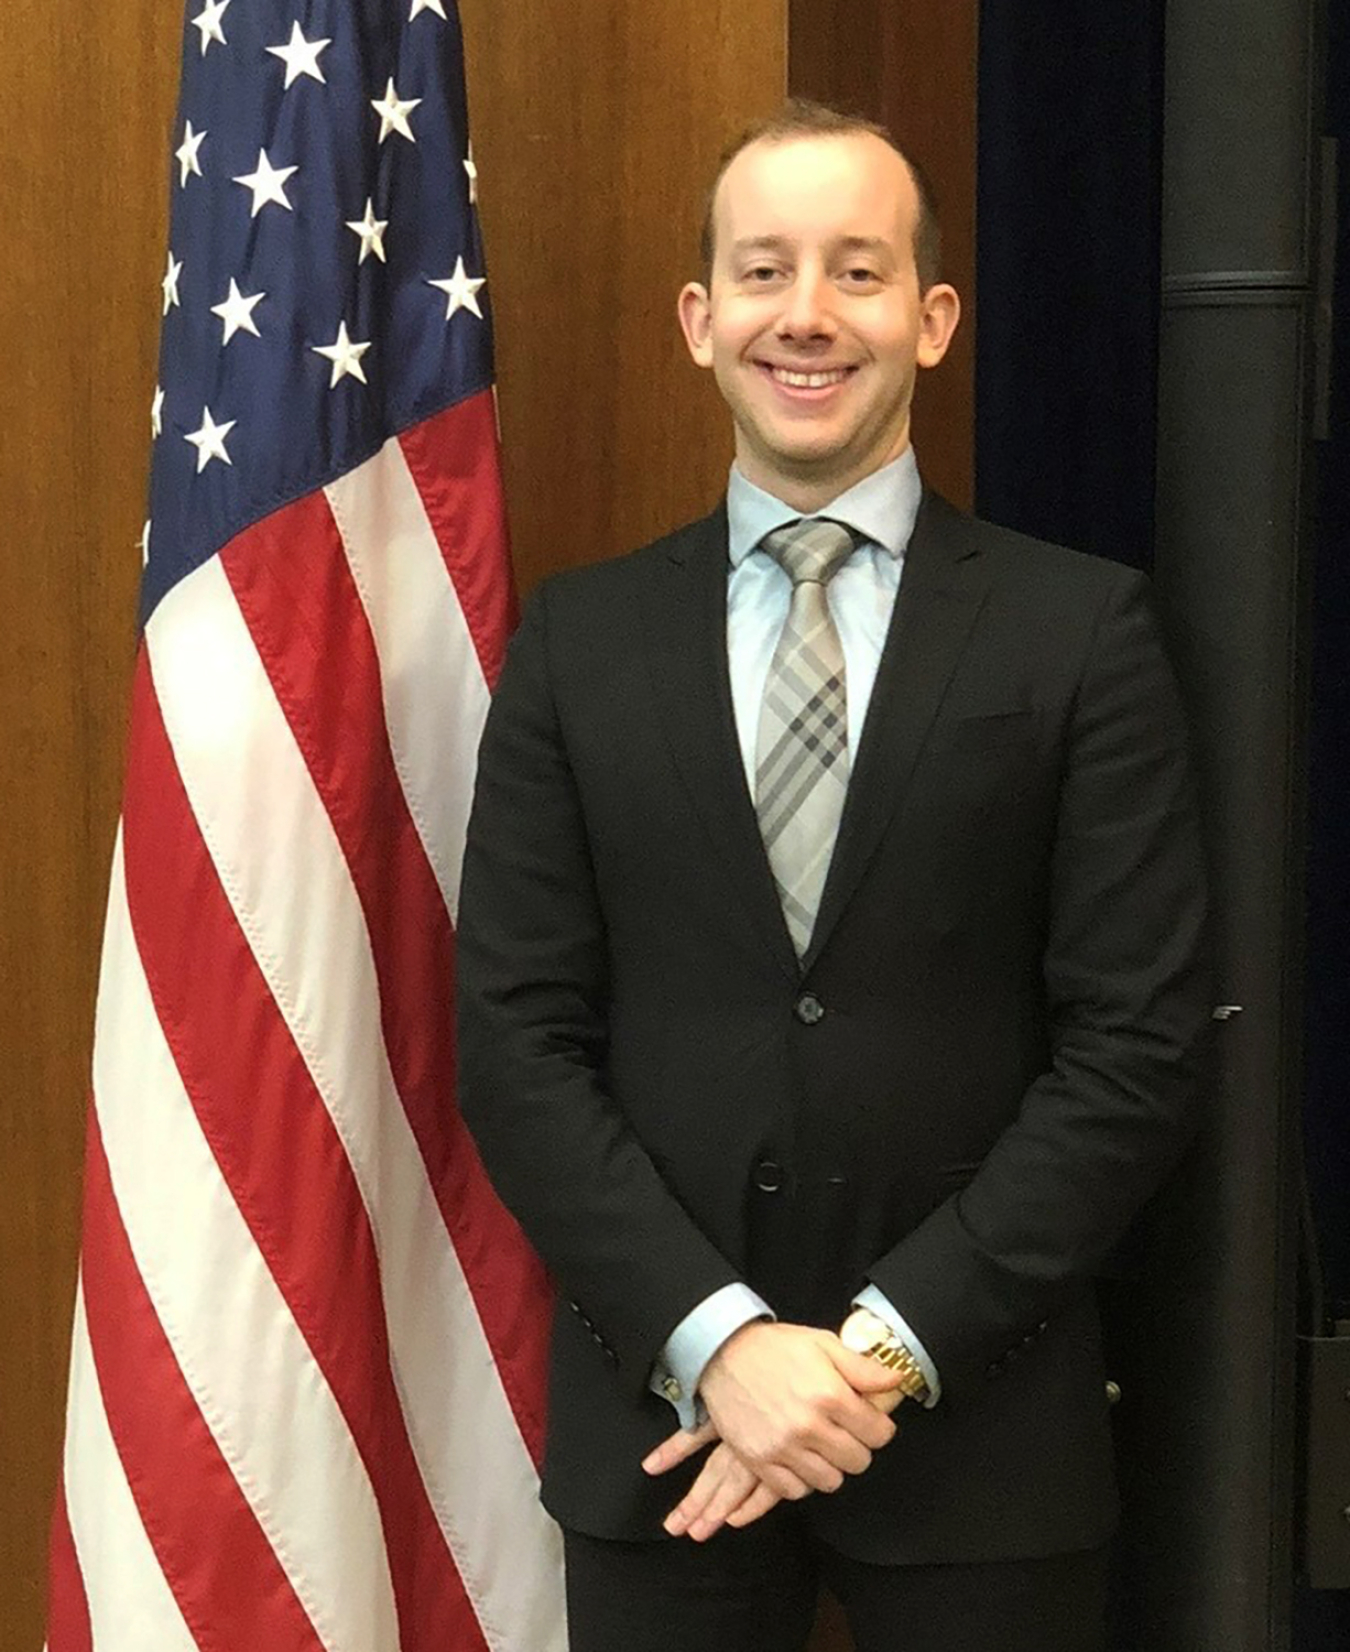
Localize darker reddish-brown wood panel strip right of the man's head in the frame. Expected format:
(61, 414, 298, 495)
(788, 0, 980, 509)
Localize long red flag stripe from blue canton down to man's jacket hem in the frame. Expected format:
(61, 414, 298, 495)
(223, 494, 550, 1462)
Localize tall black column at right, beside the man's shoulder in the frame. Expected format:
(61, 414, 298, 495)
(1122, 0, 1314, 1652)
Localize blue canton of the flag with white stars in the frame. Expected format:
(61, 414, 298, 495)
(142, 0, 492, 621)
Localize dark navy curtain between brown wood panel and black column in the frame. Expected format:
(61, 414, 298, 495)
(975, 0, 1163, 568)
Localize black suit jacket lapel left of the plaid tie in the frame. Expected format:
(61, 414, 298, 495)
(643, 507, 800, 980)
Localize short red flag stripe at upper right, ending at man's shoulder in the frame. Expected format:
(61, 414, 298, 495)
(398, 390, 516, 689)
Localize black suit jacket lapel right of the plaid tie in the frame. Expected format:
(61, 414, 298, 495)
(801, 491, 985, 971)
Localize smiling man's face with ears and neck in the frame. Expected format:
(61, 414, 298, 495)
(679, 134, 960, 509)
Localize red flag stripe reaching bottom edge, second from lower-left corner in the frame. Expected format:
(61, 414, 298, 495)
(83, 1117, 322, 1652)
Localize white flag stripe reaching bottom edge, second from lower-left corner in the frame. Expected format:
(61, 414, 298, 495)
(94, 832, 398, 1652)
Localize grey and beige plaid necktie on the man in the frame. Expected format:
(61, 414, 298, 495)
(755, 520, 854, 958)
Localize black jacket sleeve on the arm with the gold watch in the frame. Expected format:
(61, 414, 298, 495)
(868, 572, 1213, 1403)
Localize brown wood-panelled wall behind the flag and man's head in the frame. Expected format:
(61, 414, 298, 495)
(0, 0, 973, 1649)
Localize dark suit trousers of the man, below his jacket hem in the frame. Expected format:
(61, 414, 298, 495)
(563, 1507, 1107, 1652)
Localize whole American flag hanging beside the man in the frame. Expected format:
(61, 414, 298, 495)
(48, 0, 565, 1652)
